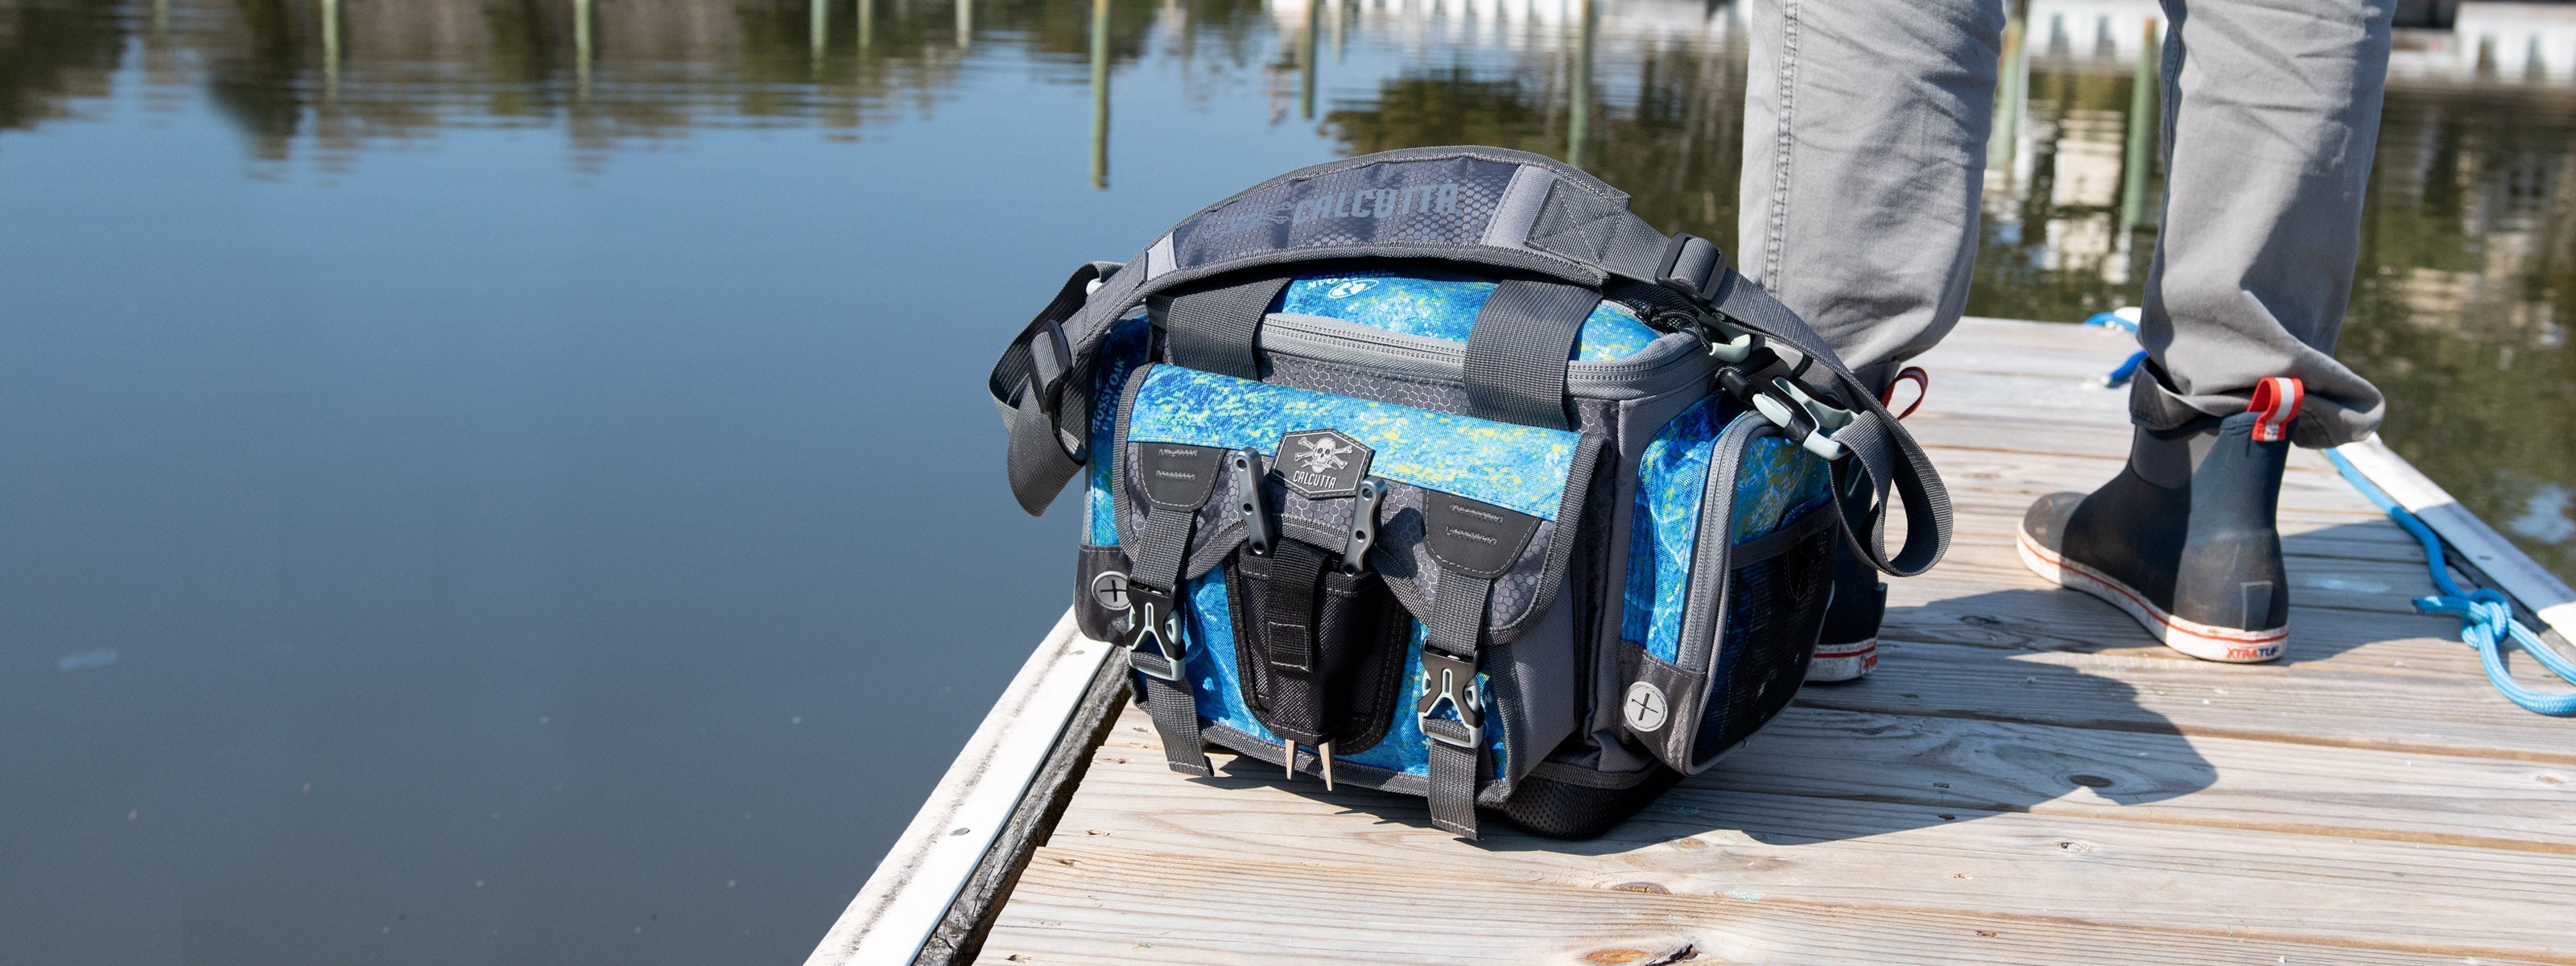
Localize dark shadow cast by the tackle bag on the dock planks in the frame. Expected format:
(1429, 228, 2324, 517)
(1213, 590, 2220, 855)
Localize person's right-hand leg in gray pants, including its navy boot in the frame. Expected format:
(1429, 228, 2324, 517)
(2020, 0, 2393, 662)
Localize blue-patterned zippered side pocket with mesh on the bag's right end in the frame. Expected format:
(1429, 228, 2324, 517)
(1620, 397, 1837, 773)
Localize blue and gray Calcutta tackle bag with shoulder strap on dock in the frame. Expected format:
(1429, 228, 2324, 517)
(989, 147, 1950, 837)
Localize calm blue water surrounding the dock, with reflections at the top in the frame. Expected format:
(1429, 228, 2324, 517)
(0, 0, 2576, 964)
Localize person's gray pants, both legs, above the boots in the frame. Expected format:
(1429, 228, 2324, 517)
(1736, 0, 2393, 446)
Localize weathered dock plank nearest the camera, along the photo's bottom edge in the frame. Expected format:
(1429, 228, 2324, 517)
(987, 842, 2566, 966)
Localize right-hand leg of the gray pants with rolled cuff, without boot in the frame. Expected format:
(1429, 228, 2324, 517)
(2130, 0, 2396, 446)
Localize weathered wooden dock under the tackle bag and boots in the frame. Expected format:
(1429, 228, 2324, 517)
(816, 320, 2576, 966)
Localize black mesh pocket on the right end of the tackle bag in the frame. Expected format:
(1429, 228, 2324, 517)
(1692, 528, 1837, 762)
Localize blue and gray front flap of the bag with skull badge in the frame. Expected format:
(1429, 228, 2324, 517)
(1113, 365, 1602, 644)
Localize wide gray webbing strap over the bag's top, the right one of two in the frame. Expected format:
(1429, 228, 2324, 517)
(1466, 279, 1602, 430)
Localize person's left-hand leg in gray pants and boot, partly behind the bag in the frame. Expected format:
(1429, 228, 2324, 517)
(1734, 0, 2004, 680)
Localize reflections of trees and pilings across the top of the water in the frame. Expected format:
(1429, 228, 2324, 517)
(0, 0, 2576, 575)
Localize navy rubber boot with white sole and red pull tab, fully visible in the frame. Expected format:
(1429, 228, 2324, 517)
(2020, 378, 2301, 662)
